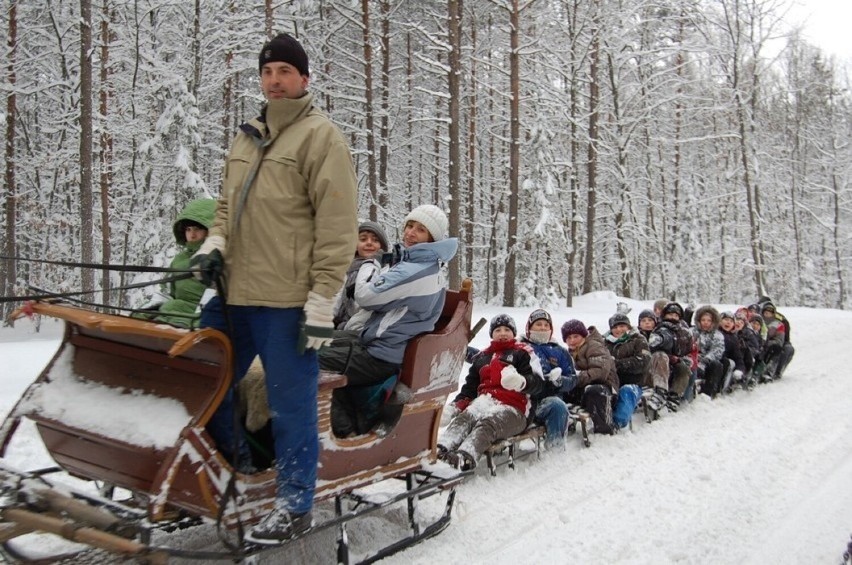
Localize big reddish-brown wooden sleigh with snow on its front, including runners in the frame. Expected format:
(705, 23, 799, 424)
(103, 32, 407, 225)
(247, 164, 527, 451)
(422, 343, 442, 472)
(0, 280, 473, 563)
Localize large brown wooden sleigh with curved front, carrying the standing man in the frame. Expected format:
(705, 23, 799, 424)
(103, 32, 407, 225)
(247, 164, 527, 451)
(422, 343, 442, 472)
(0, 281, 472, 555)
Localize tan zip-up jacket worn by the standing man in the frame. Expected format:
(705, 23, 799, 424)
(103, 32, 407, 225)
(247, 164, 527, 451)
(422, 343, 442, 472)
(215, 93, 358, 308)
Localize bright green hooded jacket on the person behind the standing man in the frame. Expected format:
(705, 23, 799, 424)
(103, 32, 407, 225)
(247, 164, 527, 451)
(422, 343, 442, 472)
(154, 198, 216, 328)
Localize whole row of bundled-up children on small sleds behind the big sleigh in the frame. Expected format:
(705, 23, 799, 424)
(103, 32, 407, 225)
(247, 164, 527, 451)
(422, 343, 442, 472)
(438, 301, 792, 469)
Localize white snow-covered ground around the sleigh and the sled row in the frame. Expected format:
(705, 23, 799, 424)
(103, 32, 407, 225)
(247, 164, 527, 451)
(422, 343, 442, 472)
(0, 292, 852, 564)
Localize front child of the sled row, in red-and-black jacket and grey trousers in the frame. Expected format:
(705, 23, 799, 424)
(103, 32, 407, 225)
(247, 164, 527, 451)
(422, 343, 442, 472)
(438, 314, 544, 470)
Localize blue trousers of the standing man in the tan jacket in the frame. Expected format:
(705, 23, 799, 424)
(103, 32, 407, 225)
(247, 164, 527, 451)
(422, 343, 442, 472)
(200, 296, 319, 513)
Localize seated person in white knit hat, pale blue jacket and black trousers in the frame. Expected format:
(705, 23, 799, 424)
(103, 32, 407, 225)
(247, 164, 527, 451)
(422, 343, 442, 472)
(319, 204, 458, 437)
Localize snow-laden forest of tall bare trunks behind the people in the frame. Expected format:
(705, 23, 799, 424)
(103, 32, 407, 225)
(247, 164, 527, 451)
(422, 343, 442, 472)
(0, 0, 852, 318)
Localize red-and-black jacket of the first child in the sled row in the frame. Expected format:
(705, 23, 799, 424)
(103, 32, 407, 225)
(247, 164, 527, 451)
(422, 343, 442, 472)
(453, 339, 544, 416)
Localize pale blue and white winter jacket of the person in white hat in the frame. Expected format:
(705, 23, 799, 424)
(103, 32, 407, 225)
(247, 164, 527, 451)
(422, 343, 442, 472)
(355, 238, 458, 363)
